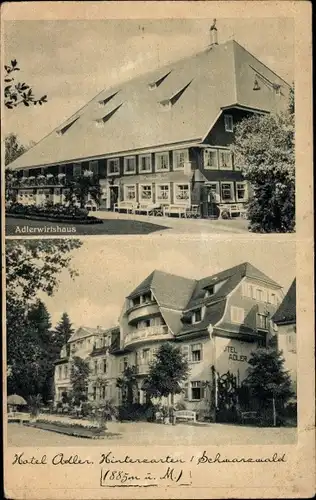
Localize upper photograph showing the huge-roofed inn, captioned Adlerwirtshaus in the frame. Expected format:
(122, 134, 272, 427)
(2, 18, 295, 237)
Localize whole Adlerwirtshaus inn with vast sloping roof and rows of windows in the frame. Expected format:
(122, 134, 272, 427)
(9, 29, 290, 217)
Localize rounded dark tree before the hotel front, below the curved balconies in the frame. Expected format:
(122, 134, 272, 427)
(144, 343, 189, 406)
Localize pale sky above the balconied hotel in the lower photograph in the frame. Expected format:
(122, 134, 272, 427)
(39, 235, 295, 328)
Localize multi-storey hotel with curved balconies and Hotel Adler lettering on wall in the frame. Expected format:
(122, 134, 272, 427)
(55, 263, 296, 411)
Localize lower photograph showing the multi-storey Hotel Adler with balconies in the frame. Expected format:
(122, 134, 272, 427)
(6, 236, 297, 447)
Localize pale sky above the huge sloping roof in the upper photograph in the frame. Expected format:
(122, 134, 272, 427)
(4, 17, 294, 144)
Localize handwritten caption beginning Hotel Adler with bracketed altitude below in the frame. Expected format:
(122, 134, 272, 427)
(12, 450, 287, 488)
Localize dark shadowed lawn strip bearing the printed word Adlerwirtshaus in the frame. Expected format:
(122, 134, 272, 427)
(5, 217, 169, 237)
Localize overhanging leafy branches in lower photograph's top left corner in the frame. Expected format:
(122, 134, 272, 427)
(6, 239, 82, 301)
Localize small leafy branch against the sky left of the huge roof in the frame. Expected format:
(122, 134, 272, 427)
(4, 59, 47, 109)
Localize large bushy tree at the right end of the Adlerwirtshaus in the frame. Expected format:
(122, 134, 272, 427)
(232, 91, 295, 233)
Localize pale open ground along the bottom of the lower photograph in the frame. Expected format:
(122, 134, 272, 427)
(8, 422, 297, 447)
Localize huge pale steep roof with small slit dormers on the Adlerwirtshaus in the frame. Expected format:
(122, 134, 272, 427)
(10, 40, 287, 169)
